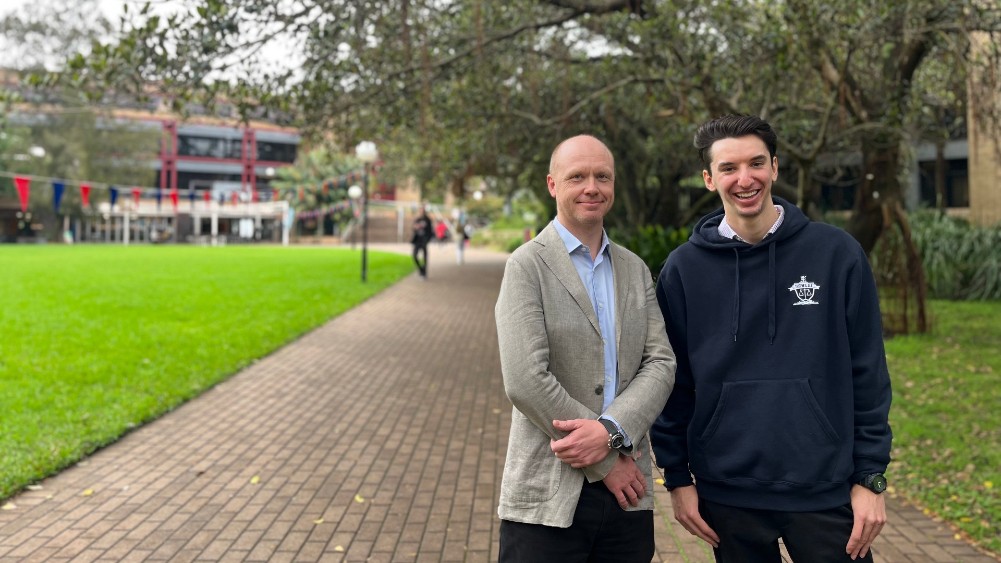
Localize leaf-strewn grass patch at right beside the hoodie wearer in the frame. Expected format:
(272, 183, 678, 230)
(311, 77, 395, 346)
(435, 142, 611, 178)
(886, 302, 1001, 553)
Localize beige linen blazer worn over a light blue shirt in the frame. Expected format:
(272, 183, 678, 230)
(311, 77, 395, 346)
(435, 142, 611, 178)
(494, 222, 676, 528)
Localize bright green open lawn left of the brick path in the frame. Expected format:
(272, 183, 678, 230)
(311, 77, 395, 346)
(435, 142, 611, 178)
(0, 244, 412, 499)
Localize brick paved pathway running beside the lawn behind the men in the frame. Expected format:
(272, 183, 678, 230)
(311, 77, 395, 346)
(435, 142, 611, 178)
(0, 245, 996, 563)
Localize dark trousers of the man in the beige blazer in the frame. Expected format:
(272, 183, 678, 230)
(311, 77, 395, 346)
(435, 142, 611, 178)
(498, 481, 654, 563)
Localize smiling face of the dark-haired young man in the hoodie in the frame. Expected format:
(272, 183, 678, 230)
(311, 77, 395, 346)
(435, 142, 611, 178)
(702, 135, 779, 223)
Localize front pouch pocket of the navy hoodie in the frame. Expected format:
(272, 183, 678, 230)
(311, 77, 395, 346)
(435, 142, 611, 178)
(700, 379, 842, 485)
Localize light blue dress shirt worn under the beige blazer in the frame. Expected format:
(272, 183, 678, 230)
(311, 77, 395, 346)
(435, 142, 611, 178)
(553, 219, 633, 446)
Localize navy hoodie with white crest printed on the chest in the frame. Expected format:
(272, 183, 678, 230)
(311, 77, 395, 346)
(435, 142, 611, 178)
(650, 197, 891, 512)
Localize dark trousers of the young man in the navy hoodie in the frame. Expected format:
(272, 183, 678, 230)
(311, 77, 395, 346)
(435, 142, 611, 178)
(699, 499, 873, 563)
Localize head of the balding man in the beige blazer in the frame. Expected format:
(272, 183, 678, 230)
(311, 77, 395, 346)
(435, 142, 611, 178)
(546, 135, 616, 236)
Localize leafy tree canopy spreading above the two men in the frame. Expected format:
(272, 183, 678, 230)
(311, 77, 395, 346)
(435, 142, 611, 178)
(52, 0, 1001, 238)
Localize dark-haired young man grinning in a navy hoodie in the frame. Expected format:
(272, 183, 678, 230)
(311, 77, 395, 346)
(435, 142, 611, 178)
(651, 111, 891, 563)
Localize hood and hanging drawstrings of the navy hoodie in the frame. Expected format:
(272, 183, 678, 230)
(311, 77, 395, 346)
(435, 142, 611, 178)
(689, 196, 810, 343)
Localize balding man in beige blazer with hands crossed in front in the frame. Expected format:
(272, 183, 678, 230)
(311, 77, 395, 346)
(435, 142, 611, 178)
(495, 135, 675, 563)
